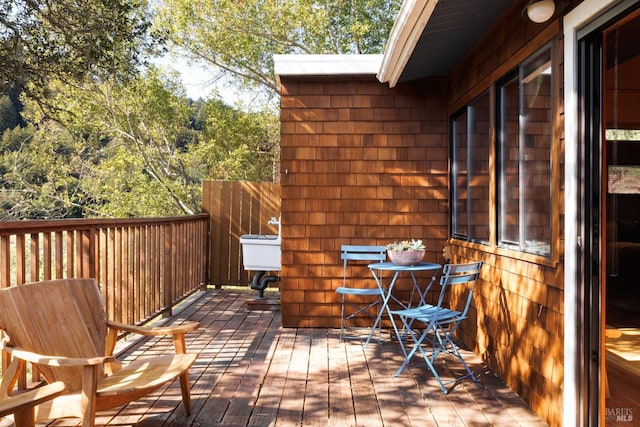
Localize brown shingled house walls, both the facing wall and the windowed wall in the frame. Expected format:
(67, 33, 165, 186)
(281, 2, 568, 426)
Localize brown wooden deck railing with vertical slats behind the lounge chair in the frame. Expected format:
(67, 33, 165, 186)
(0, 214, 209, 324)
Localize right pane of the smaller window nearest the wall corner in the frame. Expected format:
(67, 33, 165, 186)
(468, 92, 491, 243)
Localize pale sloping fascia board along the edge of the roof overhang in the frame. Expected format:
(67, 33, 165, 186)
(377, 0, 438, 87)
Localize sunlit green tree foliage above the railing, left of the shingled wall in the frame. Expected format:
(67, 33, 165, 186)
(0, 69, 278, 219)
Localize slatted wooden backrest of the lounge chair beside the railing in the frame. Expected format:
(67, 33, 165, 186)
(0, 279, 107, 392)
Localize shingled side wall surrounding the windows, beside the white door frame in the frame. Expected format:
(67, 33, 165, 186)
(448, 7, 564, 426)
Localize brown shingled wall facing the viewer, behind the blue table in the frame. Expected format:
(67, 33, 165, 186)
(280, 76, 449, 327)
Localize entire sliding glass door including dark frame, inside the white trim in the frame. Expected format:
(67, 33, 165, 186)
(579, 6, 640, 427)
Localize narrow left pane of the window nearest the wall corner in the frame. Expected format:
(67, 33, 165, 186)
(451, 111, 468, 237)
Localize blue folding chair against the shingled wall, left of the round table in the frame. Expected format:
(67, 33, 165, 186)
(336, 245, 387, 340)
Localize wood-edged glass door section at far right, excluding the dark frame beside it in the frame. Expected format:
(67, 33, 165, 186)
(601, 11, 640, 426)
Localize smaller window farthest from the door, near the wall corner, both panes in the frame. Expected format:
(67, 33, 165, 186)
(451, 91, 491, 243)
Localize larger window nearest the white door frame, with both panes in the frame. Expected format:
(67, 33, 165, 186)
(496, 48, 552, 256)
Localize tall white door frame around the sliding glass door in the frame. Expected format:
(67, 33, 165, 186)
(563, 0, 635, 427)
